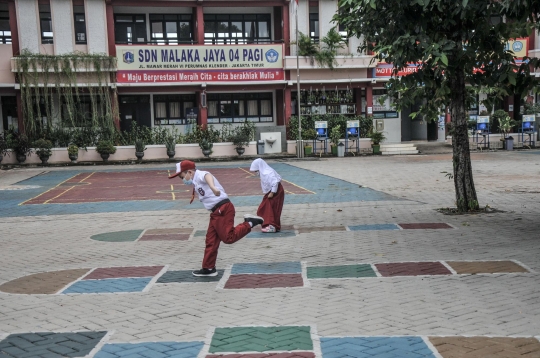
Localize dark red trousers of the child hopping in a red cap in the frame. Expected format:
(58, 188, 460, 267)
(202, 203, 251, 270)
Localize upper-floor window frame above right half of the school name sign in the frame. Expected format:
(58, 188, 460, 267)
(204, 14, 273, 45)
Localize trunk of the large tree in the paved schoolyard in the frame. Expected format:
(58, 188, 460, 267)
(450, 71, 479, 212)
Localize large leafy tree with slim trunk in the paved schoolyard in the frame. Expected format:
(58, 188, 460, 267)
(334, 0, 540, 212)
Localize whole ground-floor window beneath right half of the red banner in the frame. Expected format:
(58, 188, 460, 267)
(208, 93, 273, 123)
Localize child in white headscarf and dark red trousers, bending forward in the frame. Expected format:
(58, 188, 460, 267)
(249, 158, 285, 232)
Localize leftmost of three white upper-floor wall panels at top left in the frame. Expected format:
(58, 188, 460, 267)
(15, 0, 41, 53)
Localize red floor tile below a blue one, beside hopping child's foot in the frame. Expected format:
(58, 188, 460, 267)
(225, 274, 304, 289)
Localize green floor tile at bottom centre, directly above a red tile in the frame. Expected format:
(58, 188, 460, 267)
(209, 326, 313, 353)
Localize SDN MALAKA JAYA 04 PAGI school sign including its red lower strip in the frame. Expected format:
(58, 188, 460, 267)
(116, 44, 285, 83)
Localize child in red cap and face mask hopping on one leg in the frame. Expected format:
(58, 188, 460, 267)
(169, 160, 264, 276)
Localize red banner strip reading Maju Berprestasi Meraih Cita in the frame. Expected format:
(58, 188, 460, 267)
(116, 69, 285, 83)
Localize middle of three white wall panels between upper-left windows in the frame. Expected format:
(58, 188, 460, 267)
(51, 0, 75, 55)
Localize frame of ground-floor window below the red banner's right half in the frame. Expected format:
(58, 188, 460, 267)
(207, 92, 274, 124)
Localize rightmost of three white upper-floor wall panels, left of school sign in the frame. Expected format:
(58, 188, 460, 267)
(84, 0, 109, 54)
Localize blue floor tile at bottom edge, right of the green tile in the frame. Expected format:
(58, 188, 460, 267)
(321, 337, 435, 358)
